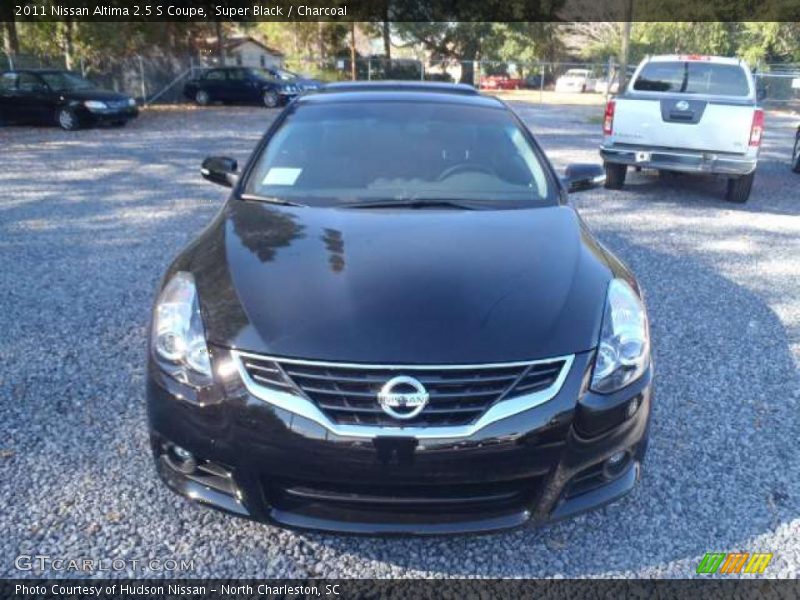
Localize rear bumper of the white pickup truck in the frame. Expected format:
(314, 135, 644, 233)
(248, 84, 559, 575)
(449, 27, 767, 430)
(600, 144, 758, 175)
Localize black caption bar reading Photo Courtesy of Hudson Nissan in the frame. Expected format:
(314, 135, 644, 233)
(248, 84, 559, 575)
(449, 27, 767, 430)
(0, 578, 800, 600)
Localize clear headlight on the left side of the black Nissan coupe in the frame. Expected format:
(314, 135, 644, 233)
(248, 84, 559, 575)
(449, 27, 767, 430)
(152, 271, 212, 386)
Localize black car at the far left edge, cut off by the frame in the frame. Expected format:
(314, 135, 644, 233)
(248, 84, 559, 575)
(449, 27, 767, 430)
(0, 69, 139, 130)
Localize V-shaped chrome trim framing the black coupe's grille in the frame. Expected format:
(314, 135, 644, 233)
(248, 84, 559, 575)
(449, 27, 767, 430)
(231, 350, 575, 439)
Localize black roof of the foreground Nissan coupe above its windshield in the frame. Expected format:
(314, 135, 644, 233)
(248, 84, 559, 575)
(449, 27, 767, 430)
(298, 81, 506, 108)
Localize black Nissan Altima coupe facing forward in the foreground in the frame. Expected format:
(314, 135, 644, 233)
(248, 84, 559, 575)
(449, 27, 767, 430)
(148, 83, 653, 534)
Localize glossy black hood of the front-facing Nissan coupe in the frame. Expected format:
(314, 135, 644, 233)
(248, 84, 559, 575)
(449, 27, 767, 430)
(192, 199, 612, 363)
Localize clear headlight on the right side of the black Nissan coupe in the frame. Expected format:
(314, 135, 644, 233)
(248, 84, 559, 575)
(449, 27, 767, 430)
(591, 279, 650, 394)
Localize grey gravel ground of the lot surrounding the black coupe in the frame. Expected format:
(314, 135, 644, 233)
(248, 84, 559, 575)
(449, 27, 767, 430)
(0, 104, 800, 578)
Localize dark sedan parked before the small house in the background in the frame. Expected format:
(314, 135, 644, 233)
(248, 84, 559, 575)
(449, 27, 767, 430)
(183, 67, 302, 108)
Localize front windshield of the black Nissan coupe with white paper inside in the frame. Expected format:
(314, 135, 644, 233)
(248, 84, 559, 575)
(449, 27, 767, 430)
(244, 101, 555, 208)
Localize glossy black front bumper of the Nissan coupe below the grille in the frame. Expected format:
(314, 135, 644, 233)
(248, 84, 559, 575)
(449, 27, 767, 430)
(148, 348, 653, 534)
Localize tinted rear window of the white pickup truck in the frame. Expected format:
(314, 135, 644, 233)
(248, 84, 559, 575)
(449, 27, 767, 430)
(633, 61, 750, 96)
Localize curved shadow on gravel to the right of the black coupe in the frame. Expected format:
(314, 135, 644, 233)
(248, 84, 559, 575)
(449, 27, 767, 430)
(307, 234, 800, 577)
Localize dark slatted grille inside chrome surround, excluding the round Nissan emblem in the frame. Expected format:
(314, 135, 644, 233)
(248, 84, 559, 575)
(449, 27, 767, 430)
(241, 354, 566, 427)
